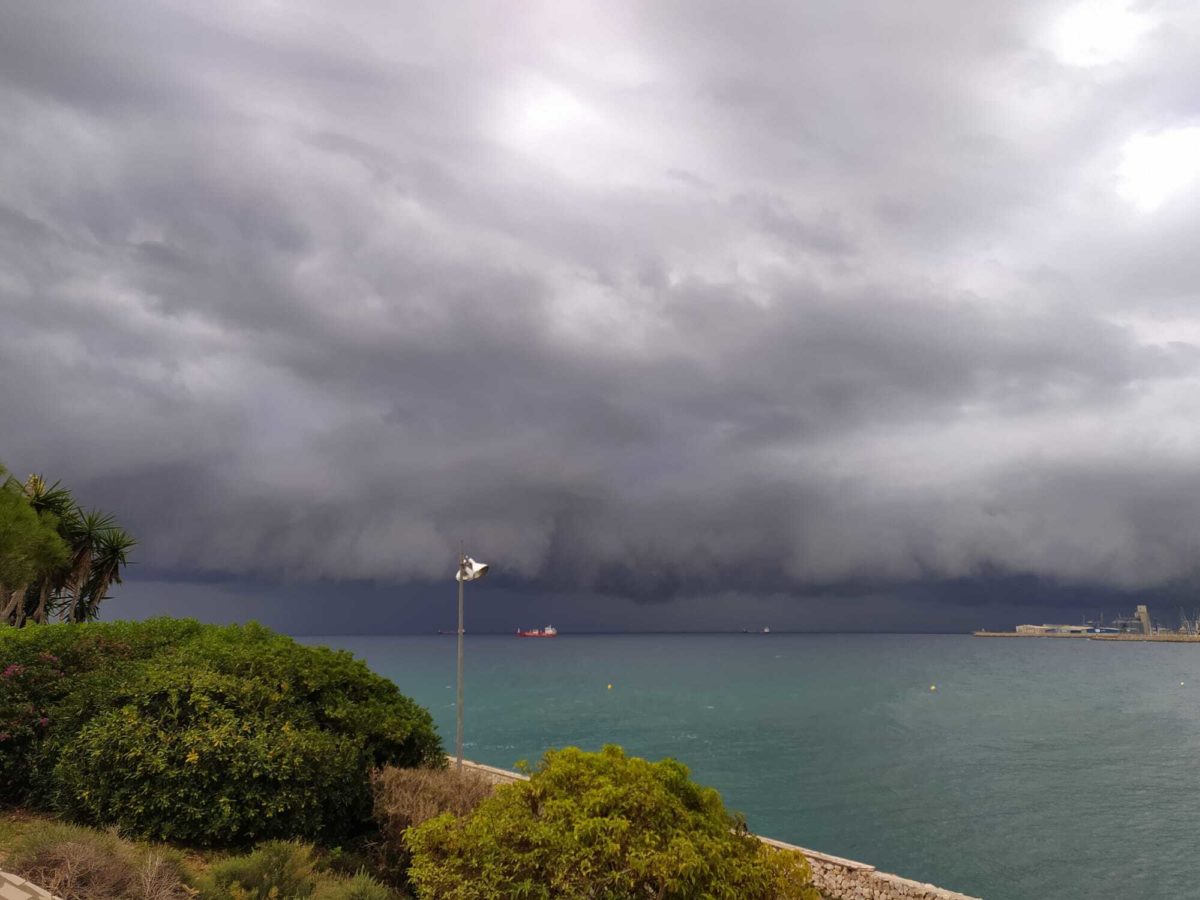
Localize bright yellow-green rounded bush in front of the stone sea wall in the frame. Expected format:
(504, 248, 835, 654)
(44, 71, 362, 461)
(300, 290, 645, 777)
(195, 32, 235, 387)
(408, 746, 817, 900)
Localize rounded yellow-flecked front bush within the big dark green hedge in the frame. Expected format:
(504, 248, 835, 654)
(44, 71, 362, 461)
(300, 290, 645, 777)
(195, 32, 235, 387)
(54, 667, 366, 844)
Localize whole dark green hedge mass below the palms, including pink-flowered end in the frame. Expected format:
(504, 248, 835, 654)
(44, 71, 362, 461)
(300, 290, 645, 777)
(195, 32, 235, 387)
(0, 619, 444, 845)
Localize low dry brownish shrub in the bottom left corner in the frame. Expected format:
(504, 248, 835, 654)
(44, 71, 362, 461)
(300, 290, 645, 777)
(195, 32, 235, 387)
(5, 823, 192, 900)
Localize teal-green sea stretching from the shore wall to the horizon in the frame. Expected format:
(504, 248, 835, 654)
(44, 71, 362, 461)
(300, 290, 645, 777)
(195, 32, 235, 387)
(297, 634, 1200, 900)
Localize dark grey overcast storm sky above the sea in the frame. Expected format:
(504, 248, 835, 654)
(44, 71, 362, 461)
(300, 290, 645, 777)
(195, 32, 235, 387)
(0, 0, 1200, 630)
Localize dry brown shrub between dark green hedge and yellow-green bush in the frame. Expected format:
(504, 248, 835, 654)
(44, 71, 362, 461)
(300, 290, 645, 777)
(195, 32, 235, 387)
(371, 766, 494, 882)
